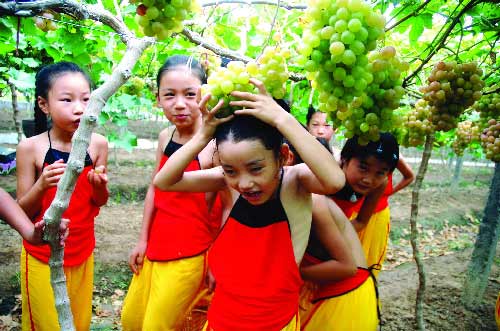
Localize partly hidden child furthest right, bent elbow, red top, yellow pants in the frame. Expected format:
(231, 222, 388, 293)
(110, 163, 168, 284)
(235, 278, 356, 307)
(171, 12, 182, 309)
(358, 157, 415, 277)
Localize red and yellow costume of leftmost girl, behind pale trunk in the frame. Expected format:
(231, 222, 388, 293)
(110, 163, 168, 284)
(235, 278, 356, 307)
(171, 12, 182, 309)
(21, 136, 99, 331)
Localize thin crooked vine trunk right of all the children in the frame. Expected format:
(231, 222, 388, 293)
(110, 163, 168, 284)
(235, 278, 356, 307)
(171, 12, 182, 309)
(410, 134, 434, 331)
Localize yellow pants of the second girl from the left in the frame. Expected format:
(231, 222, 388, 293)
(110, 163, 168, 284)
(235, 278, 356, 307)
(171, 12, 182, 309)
(121, 254, 206, 331)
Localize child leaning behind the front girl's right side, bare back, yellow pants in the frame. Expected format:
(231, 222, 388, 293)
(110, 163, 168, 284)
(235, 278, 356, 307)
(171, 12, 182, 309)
(301, 195, 378, 331)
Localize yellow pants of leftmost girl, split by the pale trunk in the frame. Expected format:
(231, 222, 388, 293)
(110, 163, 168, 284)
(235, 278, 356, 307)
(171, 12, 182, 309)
(21, 247, 94, 331)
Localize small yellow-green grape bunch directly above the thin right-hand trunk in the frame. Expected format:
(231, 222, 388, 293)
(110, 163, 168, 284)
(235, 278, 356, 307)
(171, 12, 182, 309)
(404, 99, 434, 147)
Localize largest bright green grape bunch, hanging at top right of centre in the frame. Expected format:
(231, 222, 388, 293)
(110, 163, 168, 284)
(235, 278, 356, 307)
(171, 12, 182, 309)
(296, 0, 386, 141)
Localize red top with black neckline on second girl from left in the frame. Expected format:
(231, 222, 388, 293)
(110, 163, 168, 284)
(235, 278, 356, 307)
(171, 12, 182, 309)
(146, 139, 214, 261)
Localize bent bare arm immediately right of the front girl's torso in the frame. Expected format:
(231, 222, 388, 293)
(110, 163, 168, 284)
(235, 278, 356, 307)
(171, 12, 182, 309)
(300, 195, 357, 282)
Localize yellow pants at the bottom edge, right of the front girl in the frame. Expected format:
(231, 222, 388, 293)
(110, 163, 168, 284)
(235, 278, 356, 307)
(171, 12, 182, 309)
(301, 277, 378, 331)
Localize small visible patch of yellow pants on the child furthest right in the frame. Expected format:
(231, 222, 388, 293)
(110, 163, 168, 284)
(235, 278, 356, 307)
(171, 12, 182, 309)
(358, 207, 391, 277)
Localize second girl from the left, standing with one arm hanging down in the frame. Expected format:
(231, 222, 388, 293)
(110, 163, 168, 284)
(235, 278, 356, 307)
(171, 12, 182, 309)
(121, 55, 220, 331)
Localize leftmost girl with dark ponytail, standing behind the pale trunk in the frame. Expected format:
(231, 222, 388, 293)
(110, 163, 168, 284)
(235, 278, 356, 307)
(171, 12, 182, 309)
(16, 62, 108, 331)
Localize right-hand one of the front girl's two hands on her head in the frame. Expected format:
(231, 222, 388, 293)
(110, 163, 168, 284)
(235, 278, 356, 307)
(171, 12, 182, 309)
(229, 78, 289, 127)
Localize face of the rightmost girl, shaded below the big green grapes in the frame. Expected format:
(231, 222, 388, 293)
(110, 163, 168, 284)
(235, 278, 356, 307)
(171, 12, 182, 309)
(342, 156, 390, 195)
